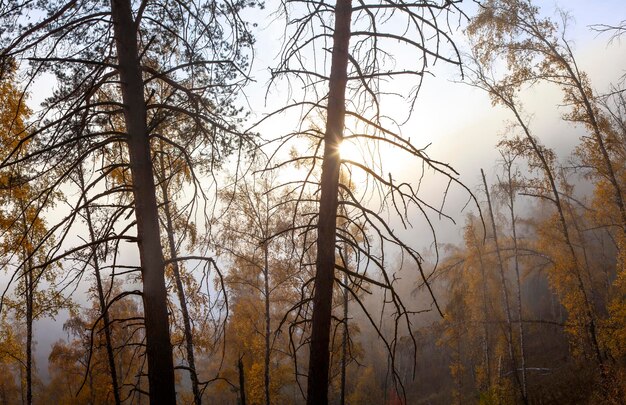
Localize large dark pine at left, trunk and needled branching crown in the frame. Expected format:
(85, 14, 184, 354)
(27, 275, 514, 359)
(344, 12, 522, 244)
(0, 0, 252, 403)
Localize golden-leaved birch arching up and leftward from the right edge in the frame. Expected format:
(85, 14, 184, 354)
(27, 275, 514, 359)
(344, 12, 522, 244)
(468, 0, 626, 237)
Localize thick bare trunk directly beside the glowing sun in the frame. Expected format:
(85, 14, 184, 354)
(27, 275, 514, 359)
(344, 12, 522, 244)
(307, 0, 352, 405)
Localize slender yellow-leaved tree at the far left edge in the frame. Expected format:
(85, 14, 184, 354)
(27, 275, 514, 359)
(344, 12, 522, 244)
(0, 63, 63, 404)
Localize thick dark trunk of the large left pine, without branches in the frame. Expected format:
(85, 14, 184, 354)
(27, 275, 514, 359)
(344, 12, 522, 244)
(111, 0, 176, 404)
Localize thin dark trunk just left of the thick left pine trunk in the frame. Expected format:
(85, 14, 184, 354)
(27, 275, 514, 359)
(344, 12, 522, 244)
(78, 165, 122, 405)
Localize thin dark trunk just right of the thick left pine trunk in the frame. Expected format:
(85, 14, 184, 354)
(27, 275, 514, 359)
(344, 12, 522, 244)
(159, 149, 202, 405)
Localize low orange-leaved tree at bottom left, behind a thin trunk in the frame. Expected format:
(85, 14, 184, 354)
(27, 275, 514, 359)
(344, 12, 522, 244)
(42, 288, 146, 404)
